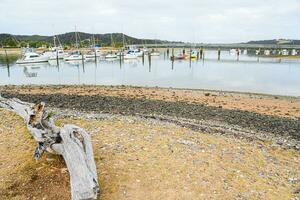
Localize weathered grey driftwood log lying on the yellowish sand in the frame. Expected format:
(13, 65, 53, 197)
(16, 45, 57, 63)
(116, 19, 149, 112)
(0, 96, 99, 200)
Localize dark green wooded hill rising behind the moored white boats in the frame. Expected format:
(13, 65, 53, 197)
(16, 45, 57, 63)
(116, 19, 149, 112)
(0, 32, 181, 47)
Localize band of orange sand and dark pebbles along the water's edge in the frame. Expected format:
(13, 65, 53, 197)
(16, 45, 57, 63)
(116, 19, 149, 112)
(0, 86, 300, 149)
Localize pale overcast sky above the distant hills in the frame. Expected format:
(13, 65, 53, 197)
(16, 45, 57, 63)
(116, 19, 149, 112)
(0, 0, 300, 42)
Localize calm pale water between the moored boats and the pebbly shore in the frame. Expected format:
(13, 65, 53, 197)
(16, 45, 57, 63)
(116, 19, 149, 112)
(0, 51, 300, 96)
